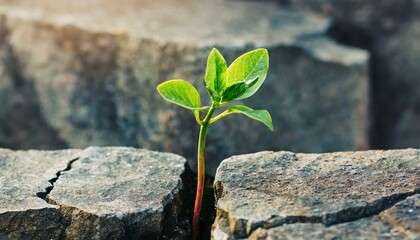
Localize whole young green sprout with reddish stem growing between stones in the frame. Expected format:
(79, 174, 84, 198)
(157, 48, 273, 240)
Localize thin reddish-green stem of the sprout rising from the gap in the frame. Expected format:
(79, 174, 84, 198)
(192, 105, 217, 240)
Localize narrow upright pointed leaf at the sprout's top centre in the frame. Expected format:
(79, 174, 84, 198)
(204, 48, 227, 100)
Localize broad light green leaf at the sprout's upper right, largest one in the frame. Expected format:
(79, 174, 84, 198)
(225, 48, 269, 100)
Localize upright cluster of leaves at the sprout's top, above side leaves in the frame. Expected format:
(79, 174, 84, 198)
(204, 48, 268, 105)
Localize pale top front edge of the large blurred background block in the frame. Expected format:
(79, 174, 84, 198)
(0, 6, 369, 68)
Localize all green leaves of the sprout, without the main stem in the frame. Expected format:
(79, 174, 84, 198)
(157, 48, 273, 130)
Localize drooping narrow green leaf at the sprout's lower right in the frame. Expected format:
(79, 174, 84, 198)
(210, 105, 273, 131)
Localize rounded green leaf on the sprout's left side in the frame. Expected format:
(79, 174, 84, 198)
(157, 79, 202, 110)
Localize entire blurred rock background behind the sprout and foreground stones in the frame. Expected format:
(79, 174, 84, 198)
(0, 0, 420, 173)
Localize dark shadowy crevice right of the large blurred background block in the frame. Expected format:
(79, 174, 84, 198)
(327, 19, 403, 149)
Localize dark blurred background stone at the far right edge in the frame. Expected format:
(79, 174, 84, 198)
(373, 19, 420, 148)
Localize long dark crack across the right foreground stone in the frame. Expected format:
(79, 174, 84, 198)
(243, 188, 420, 238)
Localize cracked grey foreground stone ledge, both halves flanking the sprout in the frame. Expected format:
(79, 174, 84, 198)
(0, 147, 420, 239)
